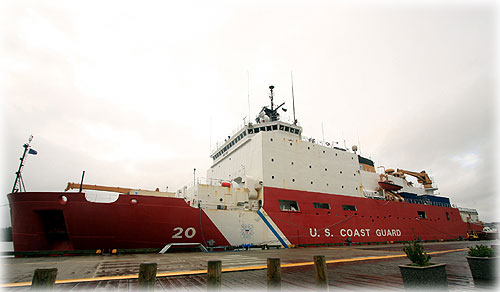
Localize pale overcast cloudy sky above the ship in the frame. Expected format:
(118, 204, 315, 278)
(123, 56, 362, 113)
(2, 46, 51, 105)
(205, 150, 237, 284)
(0, 0, 499, 226)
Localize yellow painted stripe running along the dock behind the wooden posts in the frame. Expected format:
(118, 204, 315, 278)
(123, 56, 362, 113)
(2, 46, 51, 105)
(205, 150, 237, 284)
(0, 248, 468, 288)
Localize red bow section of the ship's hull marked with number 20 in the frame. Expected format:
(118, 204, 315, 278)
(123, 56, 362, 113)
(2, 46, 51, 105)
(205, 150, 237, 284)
(8, 192, 229, 251)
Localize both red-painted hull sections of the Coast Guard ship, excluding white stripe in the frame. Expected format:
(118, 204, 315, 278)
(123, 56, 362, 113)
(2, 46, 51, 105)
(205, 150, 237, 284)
(8, 187, 482, 252)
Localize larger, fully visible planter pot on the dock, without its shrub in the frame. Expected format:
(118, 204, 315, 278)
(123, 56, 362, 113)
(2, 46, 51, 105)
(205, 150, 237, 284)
(399, 264, 448, 290)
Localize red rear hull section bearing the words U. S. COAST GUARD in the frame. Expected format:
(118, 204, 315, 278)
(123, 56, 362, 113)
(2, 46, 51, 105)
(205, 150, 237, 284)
(264, 188, 482, 245)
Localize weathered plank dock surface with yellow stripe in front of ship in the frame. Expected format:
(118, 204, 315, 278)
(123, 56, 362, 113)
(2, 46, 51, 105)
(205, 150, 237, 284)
(1, 240, 498, 291)
